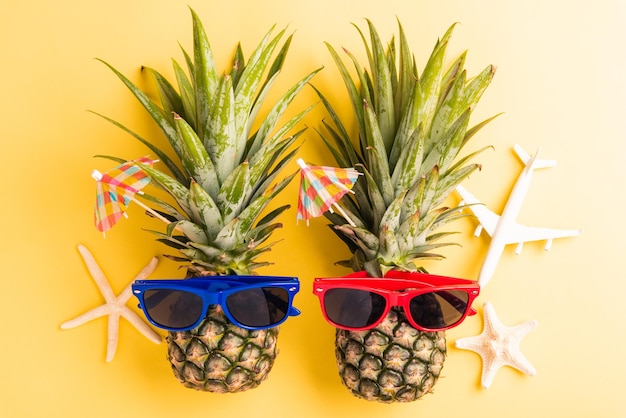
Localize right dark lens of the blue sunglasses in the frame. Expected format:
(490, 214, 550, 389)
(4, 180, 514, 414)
(226, 287, 289, 327)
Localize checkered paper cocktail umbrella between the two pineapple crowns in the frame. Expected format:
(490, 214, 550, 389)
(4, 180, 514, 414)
(297, 158, 361, 226)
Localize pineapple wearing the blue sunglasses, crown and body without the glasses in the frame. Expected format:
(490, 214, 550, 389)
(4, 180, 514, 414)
(96, 10, 317, 393)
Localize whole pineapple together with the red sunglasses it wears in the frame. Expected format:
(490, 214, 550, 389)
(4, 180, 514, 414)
(313, 21, 494, 402)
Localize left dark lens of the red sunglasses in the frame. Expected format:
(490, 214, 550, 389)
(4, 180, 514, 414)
(324, 289, 387, 328)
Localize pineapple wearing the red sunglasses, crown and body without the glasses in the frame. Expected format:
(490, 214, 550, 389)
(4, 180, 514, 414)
(316, 20, 495, 402)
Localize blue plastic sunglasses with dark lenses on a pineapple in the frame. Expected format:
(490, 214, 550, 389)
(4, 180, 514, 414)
(132, 276, 300, 331)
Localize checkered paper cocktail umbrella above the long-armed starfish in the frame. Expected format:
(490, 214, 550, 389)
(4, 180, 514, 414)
(91, 157, 169, 234)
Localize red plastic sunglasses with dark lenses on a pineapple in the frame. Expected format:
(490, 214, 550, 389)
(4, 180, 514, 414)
(313, 271, 480, 332)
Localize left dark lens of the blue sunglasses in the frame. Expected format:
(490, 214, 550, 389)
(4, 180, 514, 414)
(143, 289, 202, 329)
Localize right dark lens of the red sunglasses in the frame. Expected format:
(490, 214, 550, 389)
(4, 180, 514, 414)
(409, 290, 469, 329)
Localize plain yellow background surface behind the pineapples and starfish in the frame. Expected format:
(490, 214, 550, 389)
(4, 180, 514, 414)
(0, 0, 626, 418)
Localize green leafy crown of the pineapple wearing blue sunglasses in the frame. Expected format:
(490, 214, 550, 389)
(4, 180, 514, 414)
(95, 10, 319, 275)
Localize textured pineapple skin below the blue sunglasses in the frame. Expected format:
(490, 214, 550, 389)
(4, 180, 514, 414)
(166, 306, 279, 393)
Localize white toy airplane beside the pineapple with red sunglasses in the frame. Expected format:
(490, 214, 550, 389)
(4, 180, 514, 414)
(456, 145, 580, 287)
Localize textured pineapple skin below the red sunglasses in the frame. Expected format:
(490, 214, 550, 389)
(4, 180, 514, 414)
(335, 308, 446, 403)
